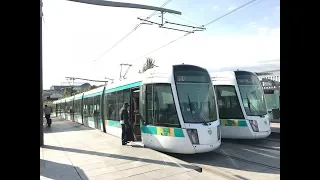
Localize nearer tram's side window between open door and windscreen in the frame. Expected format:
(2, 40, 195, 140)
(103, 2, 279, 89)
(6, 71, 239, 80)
(147, 84, 180, 127)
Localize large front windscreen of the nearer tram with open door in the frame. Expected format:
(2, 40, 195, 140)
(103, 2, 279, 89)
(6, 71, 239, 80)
(174, 65, 218, 123)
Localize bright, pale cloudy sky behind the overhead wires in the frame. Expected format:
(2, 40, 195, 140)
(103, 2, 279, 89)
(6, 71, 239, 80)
(42, 0, 280, 89)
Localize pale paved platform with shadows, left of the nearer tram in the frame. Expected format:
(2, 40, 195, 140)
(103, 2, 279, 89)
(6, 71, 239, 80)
(40, 118, 215, 180)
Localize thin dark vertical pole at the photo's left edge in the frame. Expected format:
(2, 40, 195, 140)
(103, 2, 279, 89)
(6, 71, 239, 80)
(40, 0, 44, 146)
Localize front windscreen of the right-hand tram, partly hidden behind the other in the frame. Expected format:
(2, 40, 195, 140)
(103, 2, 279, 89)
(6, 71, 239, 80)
(235, 71, 267, 116)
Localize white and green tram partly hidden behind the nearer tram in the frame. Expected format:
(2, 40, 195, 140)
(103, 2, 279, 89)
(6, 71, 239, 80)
(210, 71, 271, 139)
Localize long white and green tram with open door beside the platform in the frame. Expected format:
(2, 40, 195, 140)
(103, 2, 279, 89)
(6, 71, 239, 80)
(54, 64, 221, 154)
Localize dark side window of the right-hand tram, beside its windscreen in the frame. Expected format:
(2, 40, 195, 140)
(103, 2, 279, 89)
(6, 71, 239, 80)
(215, 85, 244, 119)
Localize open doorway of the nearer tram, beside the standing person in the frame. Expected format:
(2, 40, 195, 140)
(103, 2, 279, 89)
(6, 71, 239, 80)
(130, 87, 141, 141)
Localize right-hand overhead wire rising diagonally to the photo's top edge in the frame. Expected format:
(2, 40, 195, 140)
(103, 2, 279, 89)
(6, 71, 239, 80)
(129, 0, 257, 62)
